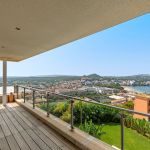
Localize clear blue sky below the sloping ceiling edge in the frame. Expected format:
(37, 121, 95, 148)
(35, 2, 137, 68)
(0, 14, 150, 76)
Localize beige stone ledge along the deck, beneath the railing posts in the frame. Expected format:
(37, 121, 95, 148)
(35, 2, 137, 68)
(16, 99, 116, 150)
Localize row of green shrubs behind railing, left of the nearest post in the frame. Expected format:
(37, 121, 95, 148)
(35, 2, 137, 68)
(40, 101, 120, 124)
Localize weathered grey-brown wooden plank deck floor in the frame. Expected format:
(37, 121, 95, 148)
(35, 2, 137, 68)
(0, 103, 78, 150)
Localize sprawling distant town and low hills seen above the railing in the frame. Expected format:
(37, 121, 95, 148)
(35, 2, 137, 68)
(0, 74, 150, 122)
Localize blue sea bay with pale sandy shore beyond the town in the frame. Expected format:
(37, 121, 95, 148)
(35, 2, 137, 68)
(126, 86, 150, 94)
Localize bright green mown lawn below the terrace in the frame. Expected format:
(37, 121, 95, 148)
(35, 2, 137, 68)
(101, 124, 150, 150)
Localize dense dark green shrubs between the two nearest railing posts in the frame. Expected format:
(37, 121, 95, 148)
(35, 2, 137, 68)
(74, 101, 120, 123)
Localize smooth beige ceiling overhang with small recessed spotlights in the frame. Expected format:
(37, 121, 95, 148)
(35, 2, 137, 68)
(0, 0, 150, 61)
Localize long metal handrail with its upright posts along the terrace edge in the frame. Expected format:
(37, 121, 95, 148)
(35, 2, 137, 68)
(17, 85, 150, 150)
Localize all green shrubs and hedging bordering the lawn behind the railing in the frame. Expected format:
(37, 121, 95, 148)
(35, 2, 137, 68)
(40, 101, 150, 138)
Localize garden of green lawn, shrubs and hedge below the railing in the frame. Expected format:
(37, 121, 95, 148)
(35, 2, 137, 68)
(39, 100, 150, 150)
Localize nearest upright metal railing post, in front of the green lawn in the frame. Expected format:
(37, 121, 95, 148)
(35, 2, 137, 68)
(120, 112, 124, 150)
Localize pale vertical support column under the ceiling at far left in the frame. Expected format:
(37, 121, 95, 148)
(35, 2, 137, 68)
(3, 61, 7, 106)
